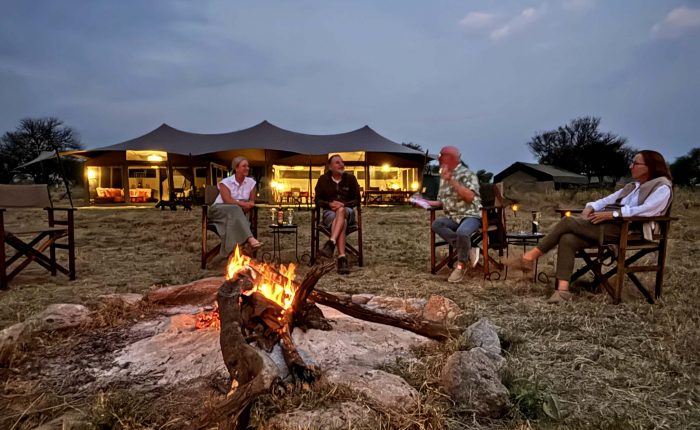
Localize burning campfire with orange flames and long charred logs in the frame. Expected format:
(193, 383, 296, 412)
(202, 248, 455, 424)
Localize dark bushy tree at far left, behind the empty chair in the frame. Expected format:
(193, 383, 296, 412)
(0, 117, 82, 184)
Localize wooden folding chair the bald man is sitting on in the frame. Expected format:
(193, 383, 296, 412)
(428, 183, 508, 279)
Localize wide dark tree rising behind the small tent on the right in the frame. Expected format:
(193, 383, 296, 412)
(527, 116, 636, 182)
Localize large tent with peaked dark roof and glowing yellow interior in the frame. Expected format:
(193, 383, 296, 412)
(72, 121, 426, 205)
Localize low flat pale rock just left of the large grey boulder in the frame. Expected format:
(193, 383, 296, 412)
(324, 365, 418, 411)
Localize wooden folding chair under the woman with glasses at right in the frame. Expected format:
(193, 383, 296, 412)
(555, 208, 678, 304)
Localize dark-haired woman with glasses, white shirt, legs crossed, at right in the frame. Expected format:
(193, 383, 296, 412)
(505, 150, 673, 303)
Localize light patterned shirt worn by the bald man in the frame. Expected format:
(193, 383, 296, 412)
(438, 164, 481, 223)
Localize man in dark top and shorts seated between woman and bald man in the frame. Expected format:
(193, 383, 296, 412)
(315, 154, 360, 275)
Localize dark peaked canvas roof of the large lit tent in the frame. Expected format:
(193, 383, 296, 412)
(71, 121, 425, 163)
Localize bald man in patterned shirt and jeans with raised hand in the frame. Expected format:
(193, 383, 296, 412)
(430, 146, 481, 282)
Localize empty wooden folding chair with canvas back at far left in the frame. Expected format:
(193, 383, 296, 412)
(0, 185, 75, 289)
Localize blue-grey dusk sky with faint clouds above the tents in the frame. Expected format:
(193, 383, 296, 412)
(0, 0, 700, 173)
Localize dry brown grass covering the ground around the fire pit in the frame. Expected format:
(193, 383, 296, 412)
(0, 191, 700, 429)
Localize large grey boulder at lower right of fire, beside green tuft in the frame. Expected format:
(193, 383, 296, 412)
(440, 348, 511, 418)
